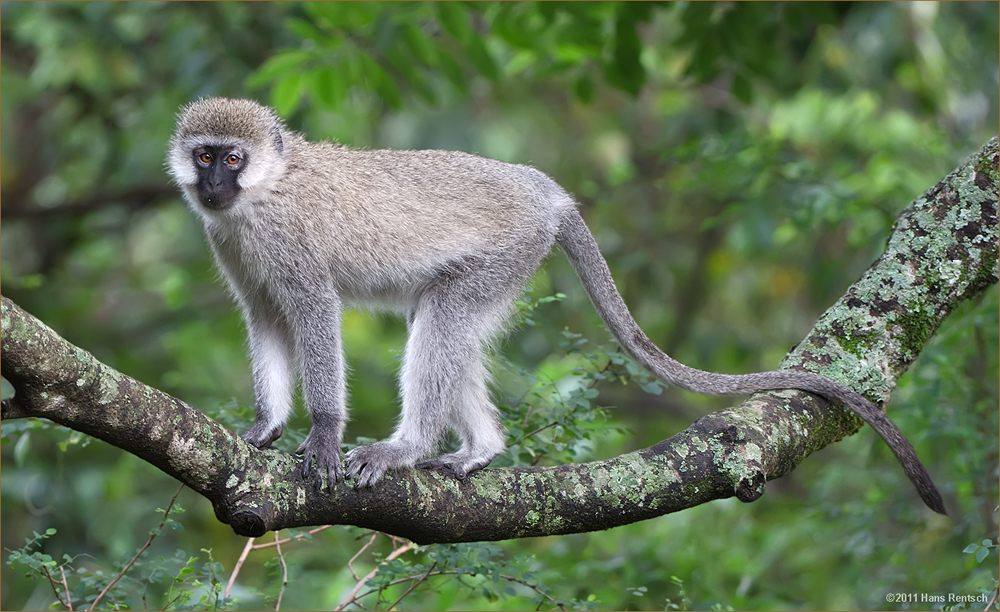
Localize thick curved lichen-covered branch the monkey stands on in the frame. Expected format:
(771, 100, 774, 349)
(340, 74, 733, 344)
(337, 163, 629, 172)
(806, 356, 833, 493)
(0, 139, 1000, 543)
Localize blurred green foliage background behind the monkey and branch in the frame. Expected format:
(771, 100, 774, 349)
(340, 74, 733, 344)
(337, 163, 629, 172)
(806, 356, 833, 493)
(0, 2, 1000, 609)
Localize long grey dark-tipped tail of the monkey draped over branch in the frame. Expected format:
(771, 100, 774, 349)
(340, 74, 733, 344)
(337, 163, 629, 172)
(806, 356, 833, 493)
(556, 207, 946, 514)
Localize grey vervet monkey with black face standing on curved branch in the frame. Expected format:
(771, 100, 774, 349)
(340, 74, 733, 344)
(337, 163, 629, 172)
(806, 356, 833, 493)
(168, 98, 944, 513)
